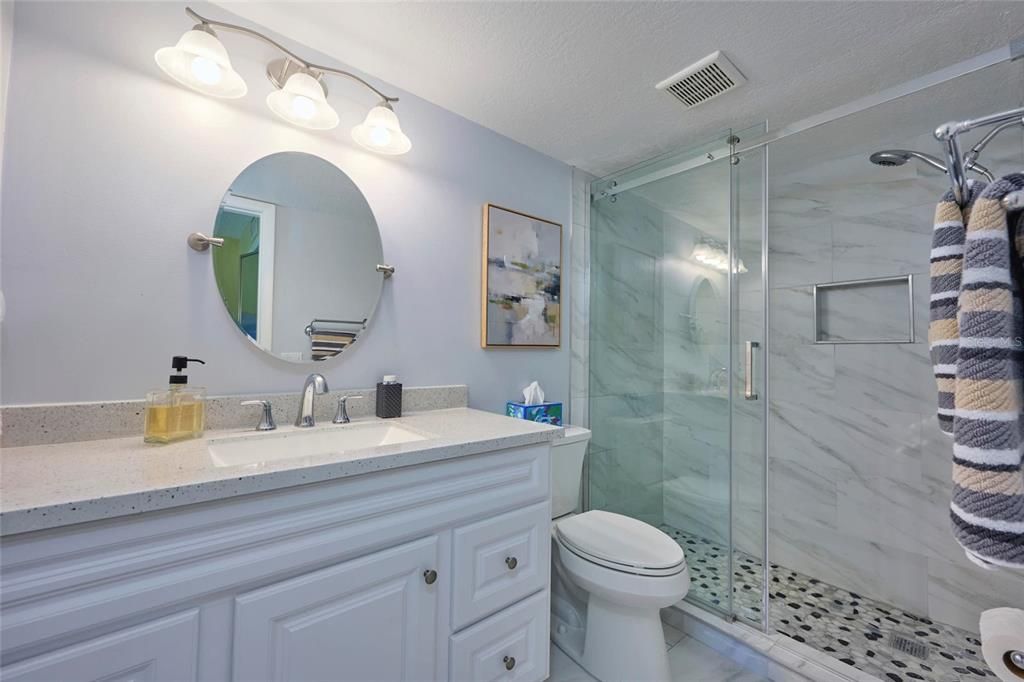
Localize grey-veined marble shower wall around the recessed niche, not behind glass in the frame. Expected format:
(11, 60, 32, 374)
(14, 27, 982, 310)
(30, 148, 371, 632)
(768, 143, 1024, 631)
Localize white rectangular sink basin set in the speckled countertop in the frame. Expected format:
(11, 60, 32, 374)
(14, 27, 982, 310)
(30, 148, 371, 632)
(209, 422, 430, 467)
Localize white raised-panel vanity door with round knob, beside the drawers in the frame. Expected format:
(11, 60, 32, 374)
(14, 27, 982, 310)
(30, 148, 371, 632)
(233, 536, 442, 682)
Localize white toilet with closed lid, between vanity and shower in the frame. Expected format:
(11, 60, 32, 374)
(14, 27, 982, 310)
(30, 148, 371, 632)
(551, 426, 690, 682)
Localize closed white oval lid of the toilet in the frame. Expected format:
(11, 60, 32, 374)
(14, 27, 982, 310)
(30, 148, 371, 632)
(555, 510, 685, 570)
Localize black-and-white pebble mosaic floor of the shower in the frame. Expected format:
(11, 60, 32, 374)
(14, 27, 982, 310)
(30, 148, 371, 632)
(662, 525, 996, 682)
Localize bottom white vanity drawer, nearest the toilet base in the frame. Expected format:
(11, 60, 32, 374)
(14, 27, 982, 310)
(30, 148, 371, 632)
(449, 590, 551, 682)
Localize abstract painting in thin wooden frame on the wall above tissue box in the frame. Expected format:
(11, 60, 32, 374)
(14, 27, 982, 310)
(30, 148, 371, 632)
(480, 204, 562, 348)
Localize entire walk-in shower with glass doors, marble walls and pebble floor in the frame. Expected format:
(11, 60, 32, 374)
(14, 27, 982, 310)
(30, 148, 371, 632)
(585, 47, 1024, 682)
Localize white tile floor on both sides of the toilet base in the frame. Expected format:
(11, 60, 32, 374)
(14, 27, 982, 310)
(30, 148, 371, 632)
(548, 624, 770, 682)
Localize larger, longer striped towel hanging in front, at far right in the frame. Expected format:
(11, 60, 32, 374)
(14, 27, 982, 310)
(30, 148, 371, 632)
(950, 173, 1024, 568)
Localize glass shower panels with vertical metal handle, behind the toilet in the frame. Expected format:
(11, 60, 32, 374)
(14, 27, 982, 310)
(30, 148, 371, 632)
(588, 125, 766, 625)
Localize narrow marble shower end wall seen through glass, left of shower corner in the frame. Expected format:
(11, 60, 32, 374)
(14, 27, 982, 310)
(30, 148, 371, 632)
(588, 195, 665, 523)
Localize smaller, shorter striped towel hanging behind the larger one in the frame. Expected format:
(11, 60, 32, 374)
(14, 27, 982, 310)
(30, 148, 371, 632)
(928, 180, 985, 435)
